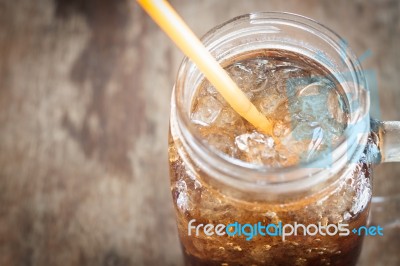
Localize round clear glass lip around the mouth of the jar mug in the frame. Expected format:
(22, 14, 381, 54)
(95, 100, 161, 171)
(173, 12, 369, 183)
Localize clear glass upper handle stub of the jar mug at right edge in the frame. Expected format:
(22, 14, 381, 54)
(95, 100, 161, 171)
(372, 121, 400, 163)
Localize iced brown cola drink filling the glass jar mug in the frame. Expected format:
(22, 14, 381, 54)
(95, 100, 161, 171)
(169, 49, 371, 266)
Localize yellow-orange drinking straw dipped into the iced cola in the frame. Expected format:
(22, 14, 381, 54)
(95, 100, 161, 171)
(137, 0, 272, 135)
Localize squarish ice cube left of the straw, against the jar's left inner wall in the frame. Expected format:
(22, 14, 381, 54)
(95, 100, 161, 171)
(191, 96, 222, 126)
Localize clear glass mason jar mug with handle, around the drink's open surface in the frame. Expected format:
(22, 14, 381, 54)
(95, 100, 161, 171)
(168, 12, 399, 266)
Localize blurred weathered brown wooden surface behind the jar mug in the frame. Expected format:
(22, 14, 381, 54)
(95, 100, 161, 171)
(0, 0, 400, 266)
